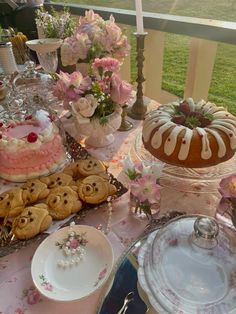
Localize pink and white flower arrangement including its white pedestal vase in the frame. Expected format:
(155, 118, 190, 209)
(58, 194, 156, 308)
(54, 57, 132, 147)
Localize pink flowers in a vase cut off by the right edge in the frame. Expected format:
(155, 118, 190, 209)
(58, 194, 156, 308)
(216, 174, 236, 228)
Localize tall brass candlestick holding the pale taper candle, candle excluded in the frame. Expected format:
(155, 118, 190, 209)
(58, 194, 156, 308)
(127, 32, 147, 120)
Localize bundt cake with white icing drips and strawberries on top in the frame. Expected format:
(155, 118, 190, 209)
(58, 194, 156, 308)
(142, 98, 236, 168)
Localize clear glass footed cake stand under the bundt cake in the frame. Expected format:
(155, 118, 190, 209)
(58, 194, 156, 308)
(131, 132, 236, 216)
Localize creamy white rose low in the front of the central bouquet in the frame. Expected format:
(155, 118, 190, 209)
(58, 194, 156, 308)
(72, 94, 98, 118)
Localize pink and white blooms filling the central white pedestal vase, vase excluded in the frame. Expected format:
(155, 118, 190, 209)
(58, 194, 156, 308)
(54, 57, 132, 124)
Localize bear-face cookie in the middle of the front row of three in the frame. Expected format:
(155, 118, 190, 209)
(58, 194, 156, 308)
(46, 186, 82, 220)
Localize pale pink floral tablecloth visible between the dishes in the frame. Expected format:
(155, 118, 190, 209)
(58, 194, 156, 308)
(0, 99, 223, 314)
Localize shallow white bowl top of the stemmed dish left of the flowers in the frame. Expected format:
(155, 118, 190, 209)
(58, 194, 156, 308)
(26, 38, 63, 53)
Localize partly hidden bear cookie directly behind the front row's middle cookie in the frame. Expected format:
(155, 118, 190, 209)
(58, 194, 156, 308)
(39, 172, 73, 189)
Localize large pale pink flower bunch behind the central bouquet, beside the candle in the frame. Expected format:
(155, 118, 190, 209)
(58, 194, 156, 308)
(61, 10, 130, 66)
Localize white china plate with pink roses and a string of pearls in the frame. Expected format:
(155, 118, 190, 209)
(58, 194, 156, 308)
(31, 225, 114, 301)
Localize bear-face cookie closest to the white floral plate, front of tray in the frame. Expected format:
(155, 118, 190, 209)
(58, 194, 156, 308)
(13, 204, 52, 240)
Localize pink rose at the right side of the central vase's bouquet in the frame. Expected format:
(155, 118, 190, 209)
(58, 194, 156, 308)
(111, 74, 132, 105)
